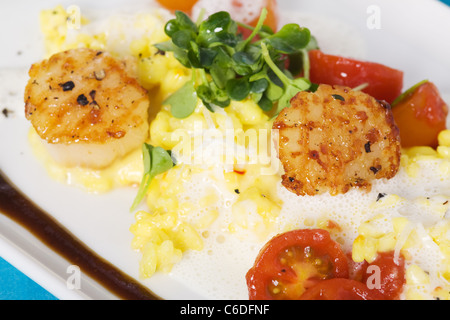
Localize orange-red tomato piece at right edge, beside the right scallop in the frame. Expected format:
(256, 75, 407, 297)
(392, 82, 448, 148)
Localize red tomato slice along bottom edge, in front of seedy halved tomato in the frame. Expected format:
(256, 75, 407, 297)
(300, 278, 385, 300)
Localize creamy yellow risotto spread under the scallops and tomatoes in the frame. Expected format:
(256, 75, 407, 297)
(33, 6, 450, 299)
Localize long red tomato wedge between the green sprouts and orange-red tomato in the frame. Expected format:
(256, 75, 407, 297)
(309, 50, 403, 103)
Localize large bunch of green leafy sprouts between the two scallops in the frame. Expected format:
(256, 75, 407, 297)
(155, 8, 318, 118)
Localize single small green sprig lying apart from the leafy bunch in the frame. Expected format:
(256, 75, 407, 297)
(130, 143, 174, 211)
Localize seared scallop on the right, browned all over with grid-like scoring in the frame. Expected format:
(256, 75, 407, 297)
(273, 85, 401, 195)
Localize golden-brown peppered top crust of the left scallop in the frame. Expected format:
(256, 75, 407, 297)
(25, 48, 148, 143)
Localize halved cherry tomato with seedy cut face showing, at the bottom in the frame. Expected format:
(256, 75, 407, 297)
(246, 229, 348, 300)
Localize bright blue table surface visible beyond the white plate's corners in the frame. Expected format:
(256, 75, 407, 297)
(0, 0, 450, 300)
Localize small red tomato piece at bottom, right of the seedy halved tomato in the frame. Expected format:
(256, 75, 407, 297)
(361, 251, 405, 300)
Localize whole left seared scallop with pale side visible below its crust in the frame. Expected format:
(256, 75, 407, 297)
(24, 48, 149, 168)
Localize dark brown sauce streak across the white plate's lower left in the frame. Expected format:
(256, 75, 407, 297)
(0, 171, 160, 300)
